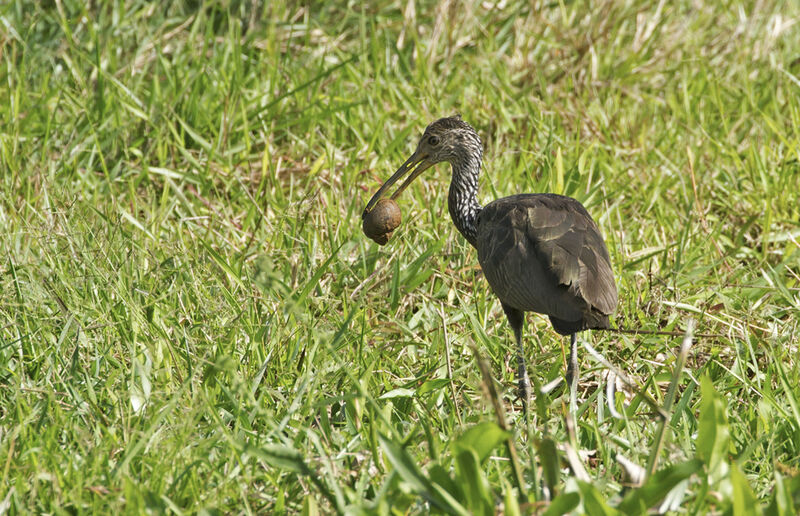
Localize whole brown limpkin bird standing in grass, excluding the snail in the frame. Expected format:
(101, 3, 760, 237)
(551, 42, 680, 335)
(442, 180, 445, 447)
(362, 115, 617, 410)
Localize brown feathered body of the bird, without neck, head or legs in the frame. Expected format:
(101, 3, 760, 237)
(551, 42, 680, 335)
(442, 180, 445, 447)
(476, 194, 617, 334)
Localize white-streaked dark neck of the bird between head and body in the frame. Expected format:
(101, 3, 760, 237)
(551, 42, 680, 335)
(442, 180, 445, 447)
(447, 152, 481, 247)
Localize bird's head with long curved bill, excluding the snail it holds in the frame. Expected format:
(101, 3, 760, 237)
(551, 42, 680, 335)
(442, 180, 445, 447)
(362, 115, 483, 217)
